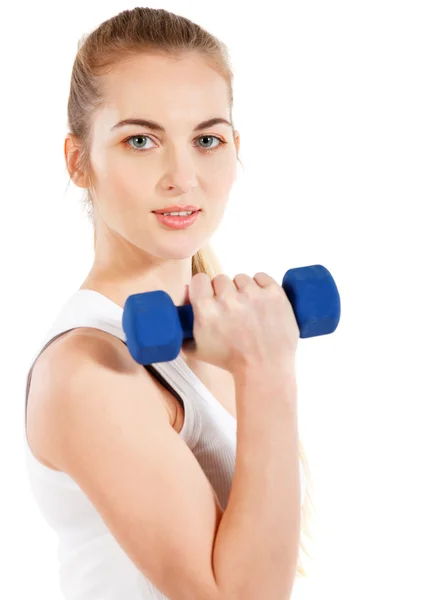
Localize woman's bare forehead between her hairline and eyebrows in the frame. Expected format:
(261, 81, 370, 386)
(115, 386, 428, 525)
(98, 54, 229, 130)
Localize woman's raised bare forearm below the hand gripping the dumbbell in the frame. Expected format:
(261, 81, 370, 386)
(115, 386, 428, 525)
(213, 360, 301, 600)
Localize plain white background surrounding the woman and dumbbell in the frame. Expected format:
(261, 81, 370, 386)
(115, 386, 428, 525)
(0, 0, 428, 600)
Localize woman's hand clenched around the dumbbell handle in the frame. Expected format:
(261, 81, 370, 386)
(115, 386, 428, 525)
(183, 272, 300, 373)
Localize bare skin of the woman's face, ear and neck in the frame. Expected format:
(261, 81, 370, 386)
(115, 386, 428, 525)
(64, 54, 239, 307)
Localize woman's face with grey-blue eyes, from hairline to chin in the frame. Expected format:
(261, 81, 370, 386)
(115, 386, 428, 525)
(83, 55, 239, 258)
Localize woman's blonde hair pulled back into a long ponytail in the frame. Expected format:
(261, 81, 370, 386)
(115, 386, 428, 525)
(68, 7, 313, 577)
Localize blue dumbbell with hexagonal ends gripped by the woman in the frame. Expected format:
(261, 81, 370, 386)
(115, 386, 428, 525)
(122, 265, 340, 365)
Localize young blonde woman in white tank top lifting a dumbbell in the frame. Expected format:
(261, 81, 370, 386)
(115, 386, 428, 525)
(26, 8, 307, 600)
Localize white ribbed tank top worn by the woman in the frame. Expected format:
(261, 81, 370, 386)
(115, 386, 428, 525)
(24, 290, 305, 600)
